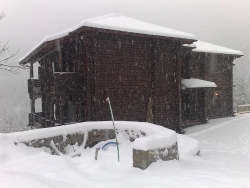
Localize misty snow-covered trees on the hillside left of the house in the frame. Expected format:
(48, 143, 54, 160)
(0, 77, 30, 133)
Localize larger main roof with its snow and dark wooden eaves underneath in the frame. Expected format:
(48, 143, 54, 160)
(18, 14, 197, 65)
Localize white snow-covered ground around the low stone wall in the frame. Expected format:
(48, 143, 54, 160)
(0, 114, 250, 188)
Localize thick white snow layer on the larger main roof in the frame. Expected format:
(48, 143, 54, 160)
(19, 14, 197, 62)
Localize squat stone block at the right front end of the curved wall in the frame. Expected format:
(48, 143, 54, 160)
(133, 143, 179, 170)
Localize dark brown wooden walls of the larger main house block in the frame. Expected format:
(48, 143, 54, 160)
(32, 27, 198, 129)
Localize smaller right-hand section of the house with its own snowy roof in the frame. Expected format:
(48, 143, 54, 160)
(182, 40, 243, 123)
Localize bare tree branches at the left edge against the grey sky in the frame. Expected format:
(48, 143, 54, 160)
(0, 12, 26, 73)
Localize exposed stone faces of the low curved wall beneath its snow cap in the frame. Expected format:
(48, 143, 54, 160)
(22, 129, 179, 170)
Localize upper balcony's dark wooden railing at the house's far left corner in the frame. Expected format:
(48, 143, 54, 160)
(28, 79, 42, 99)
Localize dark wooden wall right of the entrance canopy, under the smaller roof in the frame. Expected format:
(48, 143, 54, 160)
(205, 54, 234, 118)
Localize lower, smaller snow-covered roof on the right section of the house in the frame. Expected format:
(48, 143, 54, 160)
(183, 40, 244, 56)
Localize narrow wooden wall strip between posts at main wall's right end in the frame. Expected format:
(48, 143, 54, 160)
(154, 40, 181, 129)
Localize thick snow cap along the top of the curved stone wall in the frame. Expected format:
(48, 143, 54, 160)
(0, 121, 177, 148)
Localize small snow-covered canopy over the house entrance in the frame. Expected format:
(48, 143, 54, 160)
(181, 78, 217, 88)
